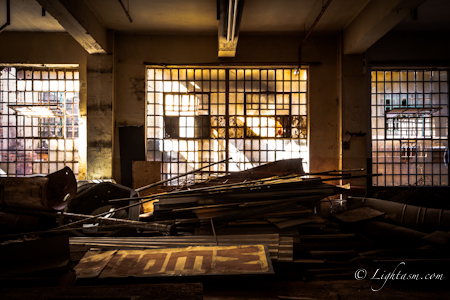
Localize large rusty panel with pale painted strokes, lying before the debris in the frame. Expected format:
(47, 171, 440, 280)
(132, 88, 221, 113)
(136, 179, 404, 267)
(76, 245, 273, 278)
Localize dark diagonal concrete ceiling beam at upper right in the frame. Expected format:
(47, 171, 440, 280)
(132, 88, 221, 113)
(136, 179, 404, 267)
(343, 0, 426, 54)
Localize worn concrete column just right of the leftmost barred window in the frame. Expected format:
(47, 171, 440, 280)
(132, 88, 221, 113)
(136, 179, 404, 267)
(86, 55, 114, 179)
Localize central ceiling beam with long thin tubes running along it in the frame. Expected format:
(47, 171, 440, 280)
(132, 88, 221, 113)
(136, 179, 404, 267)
(217, 0, 244, 57)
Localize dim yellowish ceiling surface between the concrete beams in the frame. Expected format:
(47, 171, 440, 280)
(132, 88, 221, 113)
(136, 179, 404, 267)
(0, 0, 368, 34)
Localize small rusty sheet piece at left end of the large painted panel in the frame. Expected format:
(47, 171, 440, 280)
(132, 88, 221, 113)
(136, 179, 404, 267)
(74, 250, 117, 278)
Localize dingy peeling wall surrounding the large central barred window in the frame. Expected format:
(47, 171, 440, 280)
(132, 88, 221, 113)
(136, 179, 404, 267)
(114, 34, 340, 181)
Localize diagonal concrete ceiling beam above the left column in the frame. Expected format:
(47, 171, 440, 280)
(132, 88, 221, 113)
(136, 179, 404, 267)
(36, 0, 109, 54)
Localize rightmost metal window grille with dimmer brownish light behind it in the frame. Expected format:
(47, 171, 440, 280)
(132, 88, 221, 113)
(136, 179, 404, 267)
(371, 70, 449, 186)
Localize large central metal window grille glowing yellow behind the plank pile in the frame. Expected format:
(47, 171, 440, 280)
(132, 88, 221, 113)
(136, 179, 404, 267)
(147, 68, 308, 185)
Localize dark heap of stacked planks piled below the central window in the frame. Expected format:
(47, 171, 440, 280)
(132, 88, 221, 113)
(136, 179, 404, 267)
(149, 176, 342, 232)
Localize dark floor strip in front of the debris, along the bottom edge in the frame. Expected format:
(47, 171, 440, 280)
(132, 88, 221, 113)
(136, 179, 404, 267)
(0, 276, 450, 300)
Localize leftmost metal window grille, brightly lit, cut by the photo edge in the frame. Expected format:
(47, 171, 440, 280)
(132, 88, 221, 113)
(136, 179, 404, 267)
(0, 67, 79, 176)
